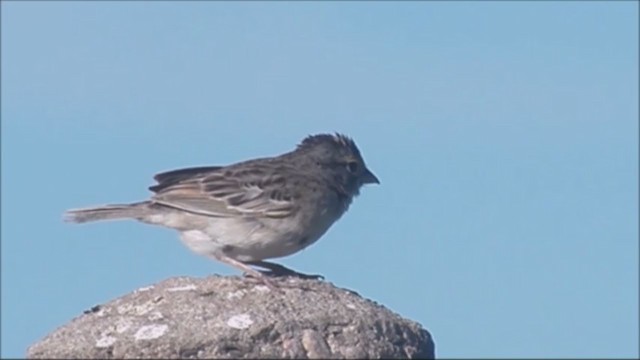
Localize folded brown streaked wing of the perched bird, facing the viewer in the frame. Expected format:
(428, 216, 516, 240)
(150, 166, 297, 218)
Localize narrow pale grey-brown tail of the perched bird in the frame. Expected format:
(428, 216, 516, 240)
(64, 201, 149, 223)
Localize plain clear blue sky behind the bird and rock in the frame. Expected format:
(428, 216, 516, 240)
(1, 1, 639, 358)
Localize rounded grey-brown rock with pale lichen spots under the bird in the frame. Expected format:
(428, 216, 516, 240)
(27, 276, 434, 359)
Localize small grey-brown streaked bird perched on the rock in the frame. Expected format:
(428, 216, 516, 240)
(64, 133, 380, 288)
